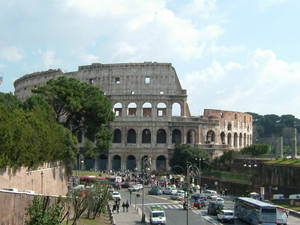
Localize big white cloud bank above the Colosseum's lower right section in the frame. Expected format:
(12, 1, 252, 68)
(182, 49, 300, 117)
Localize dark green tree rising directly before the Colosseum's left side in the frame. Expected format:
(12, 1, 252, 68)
(33, 77, 114, 160)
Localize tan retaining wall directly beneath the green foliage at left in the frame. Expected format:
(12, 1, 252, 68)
(0, 166, 67, 195)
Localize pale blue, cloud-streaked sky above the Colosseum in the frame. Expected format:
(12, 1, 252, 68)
(0, 0, 300, 118)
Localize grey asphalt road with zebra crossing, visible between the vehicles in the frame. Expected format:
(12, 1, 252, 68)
(120, 188, 300, 225)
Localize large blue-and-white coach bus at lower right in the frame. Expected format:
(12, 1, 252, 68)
(234, 197, 277, 225)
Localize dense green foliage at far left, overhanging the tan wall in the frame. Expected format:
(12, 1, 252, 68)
(0, 93, 78, 172)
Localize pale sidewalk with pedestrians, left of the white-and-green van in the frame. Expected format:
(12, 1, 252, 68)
(113, 205, 147, 225)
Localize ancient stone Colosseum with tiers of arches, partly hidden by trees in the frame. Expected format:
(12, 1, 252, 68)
(14, 62, 252, 170)
